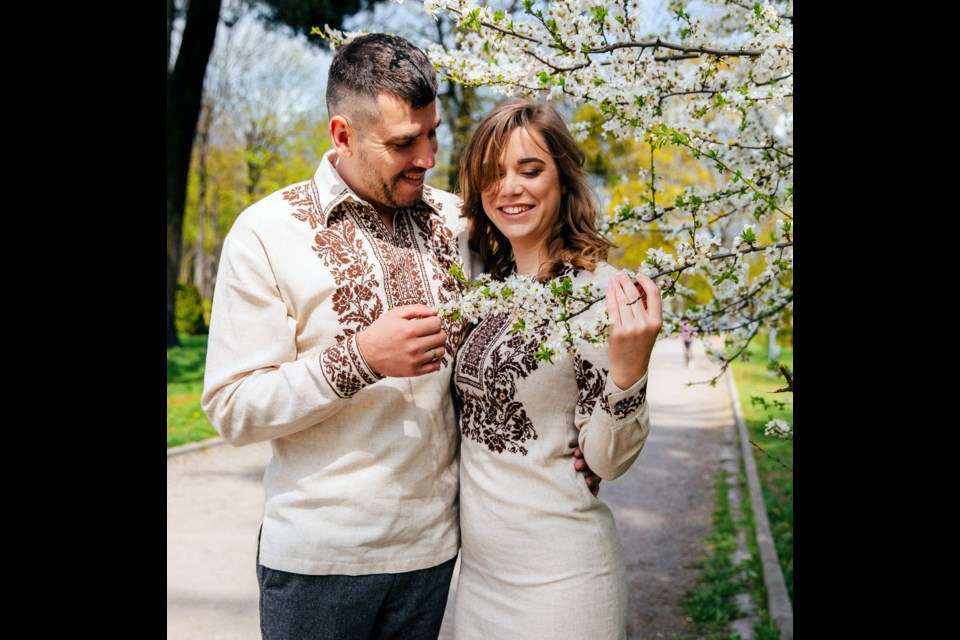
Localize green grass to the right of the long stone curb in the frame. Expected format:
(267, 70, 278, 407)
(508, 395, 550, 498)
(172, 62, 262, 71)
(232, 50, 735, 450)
(732, 345, 793, 603)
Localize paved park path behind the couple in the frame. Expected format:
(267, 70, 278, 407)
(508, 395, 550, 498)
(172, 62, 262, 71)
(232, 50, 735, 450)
(167, 339, 734, 640)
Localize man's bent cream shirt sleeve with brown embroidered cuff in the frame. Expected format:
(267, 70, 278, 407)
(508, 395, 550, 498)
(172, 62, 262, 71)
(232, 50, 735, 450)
(201, 220, 381, 446)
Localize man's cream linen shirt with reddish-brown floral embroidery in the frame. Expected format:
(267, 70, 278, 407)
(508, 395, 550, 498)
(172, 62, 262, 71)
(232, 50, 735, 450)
(202, 154, 469, 575)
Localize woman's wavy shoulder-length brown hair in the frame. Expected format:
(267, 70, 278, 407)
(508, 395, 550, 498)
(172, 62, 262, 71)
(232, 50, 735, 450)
(460, 101, 615, 282)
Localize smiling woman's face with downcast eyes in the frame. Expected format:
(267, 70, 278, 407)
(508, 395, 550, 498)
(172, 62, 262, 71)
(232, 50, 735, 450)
(481, 127, 561, 255)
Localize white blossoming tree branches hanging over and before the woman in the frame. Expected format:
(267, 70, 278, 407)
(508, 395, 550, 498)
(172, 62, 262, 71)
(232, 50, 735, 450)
(382, 0, 793, 384)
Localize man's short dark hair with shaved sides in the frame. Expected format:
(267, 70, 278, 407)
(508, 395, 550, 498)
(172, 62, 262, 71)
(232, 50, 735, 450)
(327, 33, 437, 125)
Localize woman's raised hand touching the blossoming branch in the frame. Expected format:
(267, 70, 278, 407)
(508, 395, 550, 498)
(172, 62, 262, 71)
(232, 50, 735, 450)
(606, 273, 663, 389)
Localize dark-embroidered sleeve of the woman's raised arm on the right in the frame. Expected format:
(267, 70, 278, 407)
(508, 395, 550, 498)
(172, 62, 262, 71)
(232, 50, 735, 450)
(573, 347, 650, 480)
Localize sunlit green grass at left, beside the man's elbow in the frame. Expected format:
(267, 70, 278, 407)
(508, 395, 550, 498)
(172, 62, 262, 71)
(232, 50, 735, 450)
(167, 334, 217, 447)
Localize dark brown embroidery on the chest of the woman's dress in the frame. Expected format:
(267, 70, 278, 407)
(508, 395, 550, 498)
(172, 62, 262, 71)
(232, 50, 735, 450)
(456, 313, 542, 455)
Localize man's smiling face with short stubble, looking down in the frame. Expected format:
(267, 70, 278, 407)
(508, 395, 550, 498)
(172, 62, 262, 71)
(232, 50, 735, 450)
(354, 93, 440, 210)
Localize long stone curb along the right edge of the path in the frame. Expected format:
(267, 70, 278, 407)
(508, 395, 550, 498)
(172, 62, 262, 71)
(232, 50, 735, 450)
(727, 369, 793, 640)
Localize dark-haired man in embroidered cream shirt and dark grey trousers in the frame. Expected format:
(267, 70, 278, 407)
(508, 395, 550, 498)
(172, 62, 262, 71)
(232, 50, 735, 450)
(202, 34, 598, 640)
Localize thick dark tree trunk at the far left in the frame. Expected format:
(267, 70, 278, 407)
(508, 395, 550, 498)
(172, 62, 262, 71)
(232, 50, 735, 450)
(167, 0, 221, 348)
